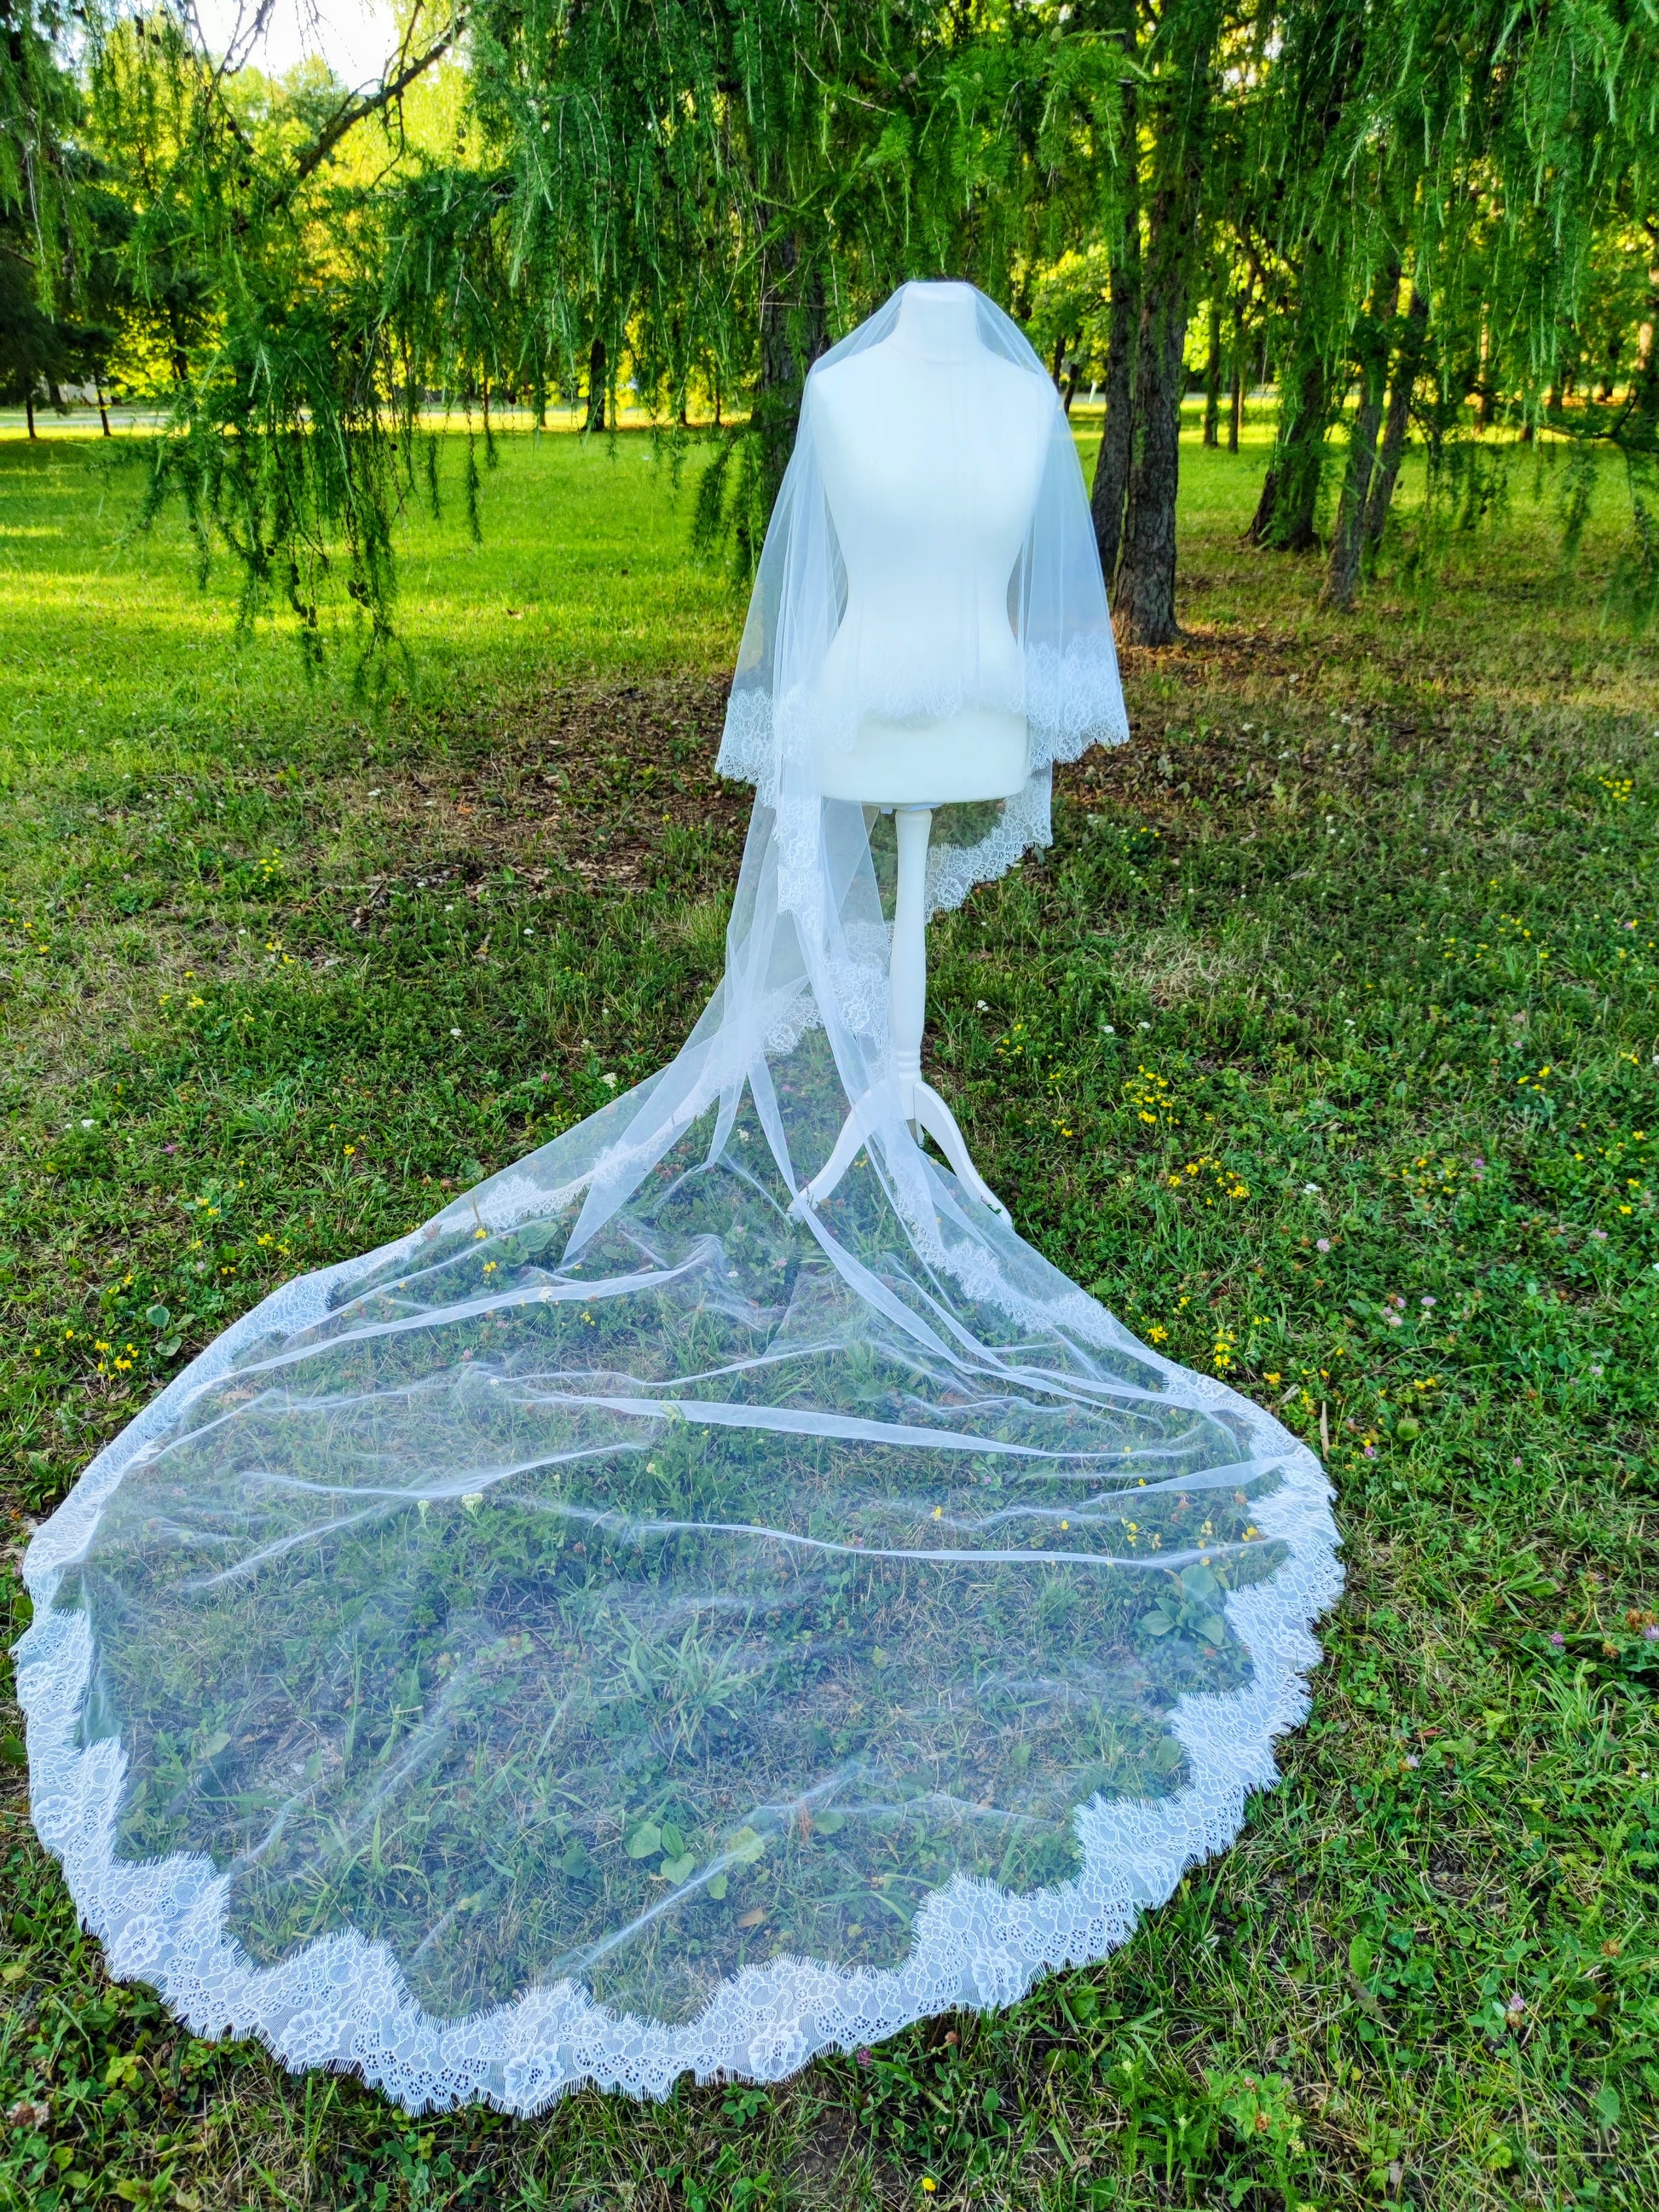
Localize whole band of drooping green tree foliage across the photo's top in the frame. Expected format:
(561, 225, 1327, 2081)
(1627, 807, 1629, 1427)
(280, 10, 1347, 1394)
(13, 0, 1659, 632)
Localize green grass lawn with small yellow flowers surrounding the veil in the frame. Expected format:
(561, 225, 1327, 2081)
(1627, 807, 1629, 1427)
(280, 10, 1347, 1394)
(0, 411, 1659, 2212)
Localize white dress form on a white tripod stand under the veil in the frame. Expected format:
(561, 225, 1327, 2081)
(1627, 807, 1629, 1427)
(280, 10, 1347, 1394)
(803, 283, 1053, 1219)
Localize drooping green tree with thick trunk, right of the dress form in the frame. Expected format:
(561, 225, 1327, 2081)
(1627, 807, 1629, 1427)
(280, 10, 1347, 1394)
(1093, 0, 1659, 644)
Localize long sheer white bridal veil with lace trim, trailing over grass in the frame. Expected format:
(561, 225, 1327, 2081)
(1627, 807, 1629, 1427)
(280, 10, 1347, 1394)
(20, 297, 1338, 2112)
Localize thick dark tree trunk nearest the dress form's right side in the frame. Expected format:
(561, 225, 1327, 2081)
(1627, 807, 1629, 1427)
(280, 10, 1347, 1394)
(1117, 188, 1197, 646)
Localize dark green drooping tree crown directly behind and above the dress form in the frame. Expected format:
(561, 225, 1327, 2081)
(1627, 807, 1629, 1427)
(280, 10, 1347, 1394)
(473, 0, 1115, 558)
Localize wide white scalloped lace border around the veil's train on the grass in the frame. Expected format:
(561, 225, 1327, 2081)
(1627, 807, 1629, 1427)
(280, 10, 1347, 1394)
(18, 1389, 1343, 2115)
